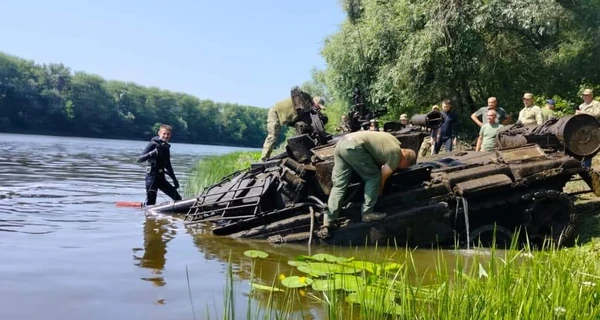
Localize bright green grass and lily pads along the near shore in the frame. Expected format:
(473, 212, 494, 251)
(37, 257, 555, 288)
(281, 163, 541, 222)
(205, 239, 600, 320)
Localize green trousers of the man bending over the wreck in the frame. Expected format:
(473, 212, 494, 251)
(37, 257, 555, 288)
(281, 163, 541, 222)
(326, 138, 381, 220)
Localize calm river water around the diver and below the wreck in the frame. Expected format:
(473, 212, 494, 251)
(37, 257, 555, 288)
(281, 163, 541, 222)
(0, 134, 466, 320)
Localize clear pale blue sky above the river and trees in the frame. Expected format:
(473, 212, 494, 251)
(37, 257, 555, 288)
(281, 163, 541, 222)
(0, 0, 345, 107)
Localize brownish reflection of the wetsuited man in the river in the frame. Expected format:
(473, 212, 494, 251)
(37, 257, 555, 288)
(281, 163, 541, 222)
(133, 216, 177, 287)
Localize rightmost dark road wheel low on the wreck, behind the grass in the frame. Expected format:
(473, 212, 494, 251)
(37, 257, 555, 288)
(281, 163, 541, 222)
(522, 190, 576, 246)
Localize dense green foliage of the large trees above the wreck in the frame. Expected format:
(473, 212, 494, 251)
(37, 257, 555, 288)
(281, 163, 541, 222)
(315, 0, 600, 133)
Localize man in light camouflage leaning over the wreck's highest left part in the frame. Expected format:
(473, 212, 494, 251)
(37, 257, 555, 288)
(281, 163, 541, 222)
(260, 97, 325, 161)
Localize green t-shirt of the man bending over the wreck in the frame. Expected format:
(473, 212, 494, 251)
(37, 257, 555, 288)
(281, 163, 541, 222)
(347, 131, 401, 170)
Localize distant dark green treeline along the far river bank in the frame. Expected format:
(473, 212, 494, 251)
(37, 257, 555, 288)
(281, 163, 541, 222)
(0, 53, 268, 147)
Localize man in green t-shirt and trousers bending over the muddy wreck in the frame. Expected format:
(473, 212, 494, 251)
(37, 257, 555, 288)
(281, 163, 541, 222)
(323, 131, 417, 228)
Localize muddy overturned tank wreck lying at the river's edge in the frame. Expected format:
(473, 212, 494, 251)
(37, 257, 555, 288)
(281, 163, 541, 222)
(147, 104, 600, 246)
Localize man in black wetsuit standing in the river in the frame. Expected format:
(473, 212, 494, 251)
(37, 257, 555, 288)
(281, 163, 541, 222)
(137, 124, 181, 206)
